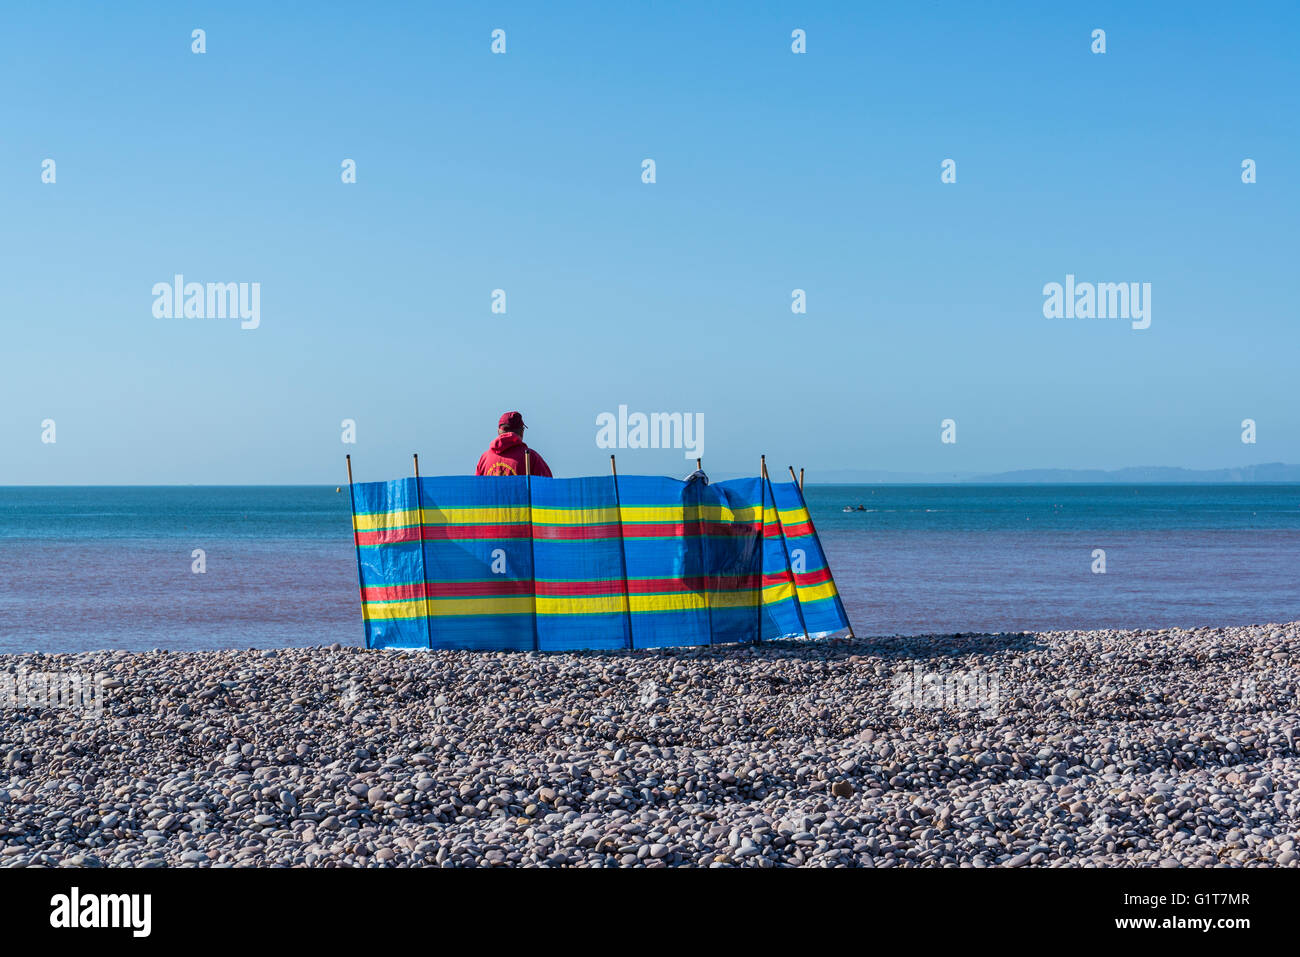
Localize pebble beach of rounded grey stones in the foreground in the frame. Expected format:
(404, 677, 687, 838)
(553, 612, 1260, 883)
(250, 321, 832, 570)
(0, 622, 1300, 867)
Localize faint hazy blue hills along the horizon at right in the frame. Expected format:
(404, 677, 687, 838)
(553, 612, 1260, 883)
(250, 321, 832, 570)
(807, 462, 1300, 485)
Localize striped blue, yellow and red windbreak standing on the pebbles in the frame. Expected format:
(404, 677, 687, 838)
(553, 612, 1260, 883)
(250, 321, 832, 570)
(351, 476, 848, 651)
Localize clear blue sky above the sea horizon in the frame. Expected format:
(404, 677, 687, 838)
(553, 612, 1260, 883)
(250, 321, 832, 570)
(0, 3, 1300, 485)
